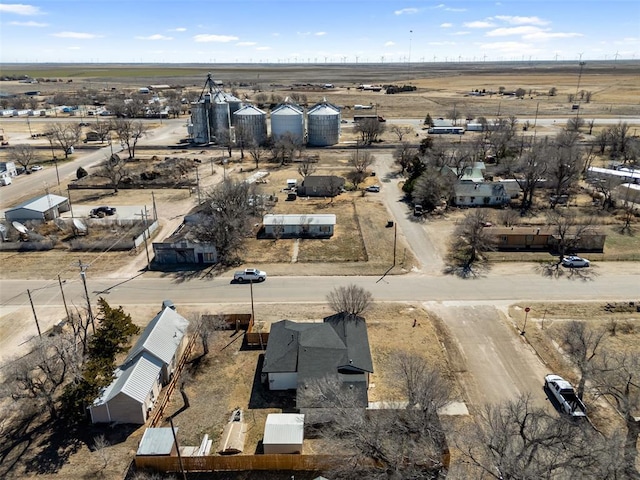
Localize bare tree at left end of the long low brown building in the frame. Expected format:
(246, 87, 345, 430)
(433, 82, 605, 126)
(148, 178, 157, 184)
(447, 209, 495, 278)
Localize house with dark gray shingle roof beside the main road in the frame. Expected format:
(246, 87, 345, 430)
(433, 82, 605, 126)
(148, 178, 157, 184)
(262, 314, 373, 408)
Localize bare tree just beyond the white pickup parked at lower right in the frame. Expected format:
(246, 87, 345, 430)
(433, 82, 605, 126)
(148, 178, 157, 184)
(560, 321, 606, 398)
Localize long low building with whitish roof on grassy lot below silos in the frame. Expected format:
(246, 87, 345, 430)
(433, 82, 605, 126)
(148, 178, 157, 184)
(262, 213, 336, 238)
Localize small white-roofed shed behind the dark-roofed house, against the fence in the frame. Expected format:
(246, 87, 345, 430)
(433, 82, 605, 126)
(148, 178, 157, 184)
(262, 413, 304, 454)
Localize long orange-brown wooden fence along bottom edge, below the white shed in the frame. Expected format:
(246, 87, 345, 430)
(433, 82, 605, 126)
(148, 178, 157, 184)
(135, 454, 336, 472)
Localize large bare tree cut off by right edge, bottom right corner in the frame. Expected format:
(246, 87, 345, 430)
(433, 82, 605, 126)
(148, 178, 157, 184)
(594, 352, 640, 479)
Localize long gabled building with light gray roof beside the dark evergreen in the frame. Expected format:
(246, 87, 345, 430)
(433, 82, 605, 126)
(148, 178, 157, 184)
(89, 306, 189, 424)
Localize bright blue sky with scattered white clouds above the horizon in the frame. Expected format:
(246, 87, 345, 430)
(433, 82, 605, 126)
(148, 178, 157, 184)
(0, 0, 640, 63)
